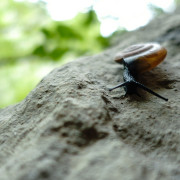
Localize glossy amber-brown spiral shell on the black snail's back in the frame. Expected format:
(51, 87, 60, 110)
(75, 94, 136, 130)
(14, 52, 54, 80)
(115, 43, 167, 73)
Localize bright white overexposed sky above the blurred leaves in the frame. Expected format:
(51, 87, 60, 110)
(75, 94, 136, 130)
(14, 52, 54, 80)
(21, 0, 175, 36)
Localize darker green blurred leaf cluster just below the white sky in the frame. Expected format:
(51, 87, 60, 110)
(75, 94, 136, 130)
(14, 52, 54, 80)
(33, 10, 109, 61)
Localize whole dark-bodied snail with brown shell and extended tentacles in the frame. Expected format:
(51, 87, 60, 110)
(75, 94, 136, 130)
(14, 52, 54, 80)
(109, 43, 168, 101)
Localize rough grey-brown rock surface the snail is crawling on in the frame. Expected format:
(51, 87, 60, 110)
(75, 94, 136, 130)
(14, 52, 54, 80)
(0, 7, 180, 180)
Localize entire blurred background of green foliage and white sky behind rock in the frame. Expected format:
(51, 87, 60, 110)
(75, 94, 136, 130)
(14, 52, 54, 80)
(0, 0, 178, 108)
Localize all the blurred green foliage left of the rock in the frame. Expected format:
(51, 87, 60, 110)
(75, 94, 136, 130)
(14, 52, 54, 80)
(0, 0, 109, 107)
